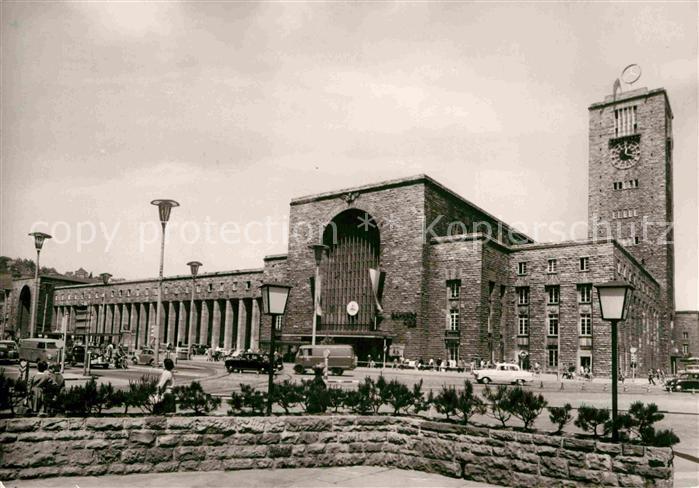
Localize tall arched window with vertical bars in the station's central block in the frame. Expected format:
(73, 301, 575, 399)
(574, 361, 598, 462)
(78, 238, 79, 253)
(320, 209, 381, 332)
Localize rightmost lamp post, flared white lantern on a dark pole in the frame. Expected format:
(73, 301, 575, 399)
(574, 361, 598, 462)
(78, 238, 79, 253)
(595, 281, 634, 442)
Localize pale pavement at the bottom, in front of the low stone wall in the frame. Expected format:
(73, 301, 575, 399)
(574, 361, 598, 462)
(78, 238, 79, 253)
(4, 466, 492, 488)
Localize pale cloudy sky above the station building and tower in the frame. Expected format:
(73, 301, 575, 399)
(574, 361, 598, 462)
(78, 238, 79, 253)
(0, 1, 699, 310)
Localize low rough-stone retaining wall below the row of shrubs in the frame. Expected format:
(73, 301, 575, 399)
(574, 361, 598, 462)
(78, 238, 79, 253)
(0, 415, 673, 487)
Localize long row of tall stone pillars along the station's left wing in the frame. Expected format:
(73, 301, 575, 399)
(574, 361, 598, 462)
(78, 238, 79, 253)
(53, 298, 261, 351)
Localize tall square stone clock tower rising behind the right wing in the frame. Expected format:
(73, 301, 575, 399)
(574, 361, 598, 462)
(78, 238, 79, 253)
(588, 88, 675, 367)
